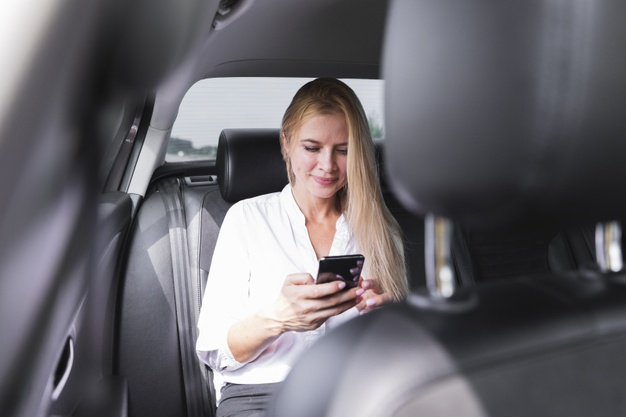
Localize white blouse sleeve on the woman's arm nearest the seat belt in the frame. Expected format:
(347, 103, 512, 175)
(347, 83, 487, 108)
(196, 204, 250, 372)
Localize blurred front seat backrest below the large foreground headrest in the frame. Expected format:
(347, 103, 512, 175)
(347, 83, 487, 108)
(269, 275, 626, 417)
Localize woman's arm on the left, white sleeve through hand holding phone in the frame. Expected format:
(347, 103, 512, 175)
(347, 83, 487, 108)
(196, 204, 356, 372)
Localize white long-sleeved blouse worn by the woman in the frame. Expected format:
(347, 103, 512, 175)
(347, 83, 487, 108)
(196, 185, 360, 396)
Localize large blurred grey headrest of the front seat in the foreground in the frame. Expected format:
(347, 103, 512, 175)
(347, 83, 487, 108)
(383, 0, 626, 228)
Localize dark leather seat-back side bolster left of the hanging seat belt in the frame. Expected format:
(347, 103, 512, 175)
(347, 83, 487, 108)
(115, 193, 186, 417)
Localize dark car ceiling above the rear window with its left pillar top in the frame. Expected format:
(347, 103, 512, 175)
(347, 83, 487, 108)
(151, 0, 387, 130)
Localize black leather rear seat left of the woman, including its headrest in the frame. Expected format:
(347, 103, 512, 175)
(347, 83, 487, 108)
(114, 129, 287, 417)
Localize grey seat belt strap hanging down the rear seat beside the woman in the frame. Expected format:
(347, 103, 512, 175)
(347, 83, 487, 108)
(159, 178, 214, 417)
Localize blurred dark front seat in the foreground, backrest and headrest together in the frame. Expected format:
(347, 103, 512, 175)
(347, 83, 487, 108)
(270, 0, 626, 417)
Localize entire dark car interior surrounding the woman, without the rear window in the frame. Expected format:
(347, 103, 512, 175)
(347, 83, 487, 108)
(0, 0, 626, 417)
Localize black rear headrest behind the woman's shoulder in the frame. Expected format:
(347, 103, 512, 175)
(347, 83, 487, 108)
(216, 129, 289, 203)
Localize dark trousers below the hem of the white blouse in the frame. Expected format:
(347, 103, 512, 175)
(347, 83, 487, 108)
(216, 383, 280, 417)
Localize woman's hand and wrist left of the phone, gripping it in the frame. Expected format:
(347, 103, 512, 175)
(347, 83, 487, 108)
(268, 273, 357, 332)
